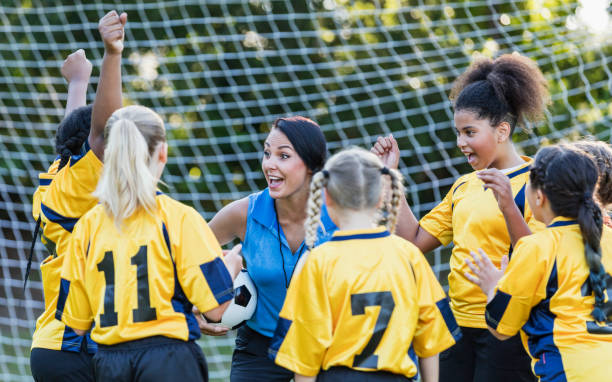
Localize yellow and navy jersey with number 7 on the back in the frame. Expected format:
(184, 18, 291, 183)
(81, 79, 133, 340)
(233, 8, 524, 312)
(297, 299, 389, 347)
(269, 227, 461, 379)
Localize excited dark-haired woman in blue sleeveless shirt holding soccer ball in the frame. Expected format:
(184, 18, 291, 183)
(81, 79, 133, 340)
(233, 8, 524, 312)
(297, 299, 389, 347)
(196, 116, 336, 382)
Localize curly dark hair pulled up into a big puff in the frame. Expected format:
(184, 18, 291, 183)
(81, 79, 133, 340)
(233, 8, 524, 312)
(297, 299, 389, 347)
(450, 54, 550, 133)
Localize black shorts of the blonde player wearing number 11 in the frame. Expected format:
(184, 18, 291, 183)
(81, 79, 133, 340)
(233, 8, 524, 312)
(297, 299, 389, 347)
(94, 336, 208, 382)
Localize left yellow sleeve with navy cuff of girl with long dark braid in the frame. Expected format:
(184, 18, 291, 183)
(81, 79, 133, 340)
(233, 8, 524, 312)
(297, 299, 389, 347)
(485, 235, 552, 336)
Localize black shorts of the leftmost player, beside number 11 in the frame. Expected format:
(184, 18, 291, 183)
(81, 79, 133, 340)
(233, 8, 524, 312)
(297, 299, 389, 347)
(30, 341, 94, 382)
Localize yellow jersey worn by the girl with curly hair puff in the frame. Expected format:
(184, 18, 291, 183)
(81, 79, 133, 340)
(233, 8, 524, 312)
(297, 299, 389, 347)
(419, 157, 544, 329)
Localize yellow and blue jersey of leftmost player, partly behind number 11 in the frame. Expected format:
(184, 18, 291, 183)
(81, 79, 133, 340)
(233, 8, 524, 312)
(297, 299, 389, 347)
(32, 143, 103, 353)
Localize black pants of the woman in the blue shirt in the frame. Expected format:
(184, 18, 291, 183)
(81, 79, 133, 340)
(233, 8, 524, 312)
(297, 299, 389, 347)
(230, 325, 293, 382)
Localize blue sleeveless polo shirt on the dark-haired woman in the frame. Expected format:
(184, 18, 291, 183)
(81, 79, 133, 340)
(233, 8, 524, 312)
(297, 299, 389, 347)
(242, 188, 337, 337)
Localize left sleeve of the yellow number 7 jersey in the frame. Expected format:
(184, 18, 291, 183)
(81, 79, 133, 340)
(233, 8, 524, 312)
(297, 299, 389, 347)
(269, 249, 332, 376)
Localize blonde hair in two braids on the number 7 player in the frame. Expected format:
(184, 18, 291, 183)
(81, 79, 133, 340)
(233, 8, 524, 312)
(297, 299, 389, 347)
(305, 147, 404, 248)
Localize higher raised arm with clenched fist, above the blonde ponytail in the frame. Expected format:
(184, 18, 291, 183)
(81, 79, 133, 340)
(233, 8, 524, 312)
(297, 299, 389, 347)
(89, 11, 127, 159)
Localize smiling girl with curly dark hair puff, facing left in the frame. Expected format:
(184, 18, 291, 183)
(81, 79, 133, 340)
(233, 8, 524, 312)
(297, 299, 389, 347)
(372, 54, 549, 382)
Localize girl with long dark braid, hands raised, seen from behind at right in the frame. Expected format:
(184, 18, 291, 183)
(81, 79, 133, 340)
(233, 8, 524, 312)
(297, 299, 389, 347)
(466, 145, 612, 382)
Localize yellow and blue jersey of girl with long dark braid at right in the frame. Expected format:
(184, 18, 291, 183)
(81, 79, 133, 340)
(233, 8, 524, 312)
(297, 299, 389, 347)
(486, 217, 612, 382)
